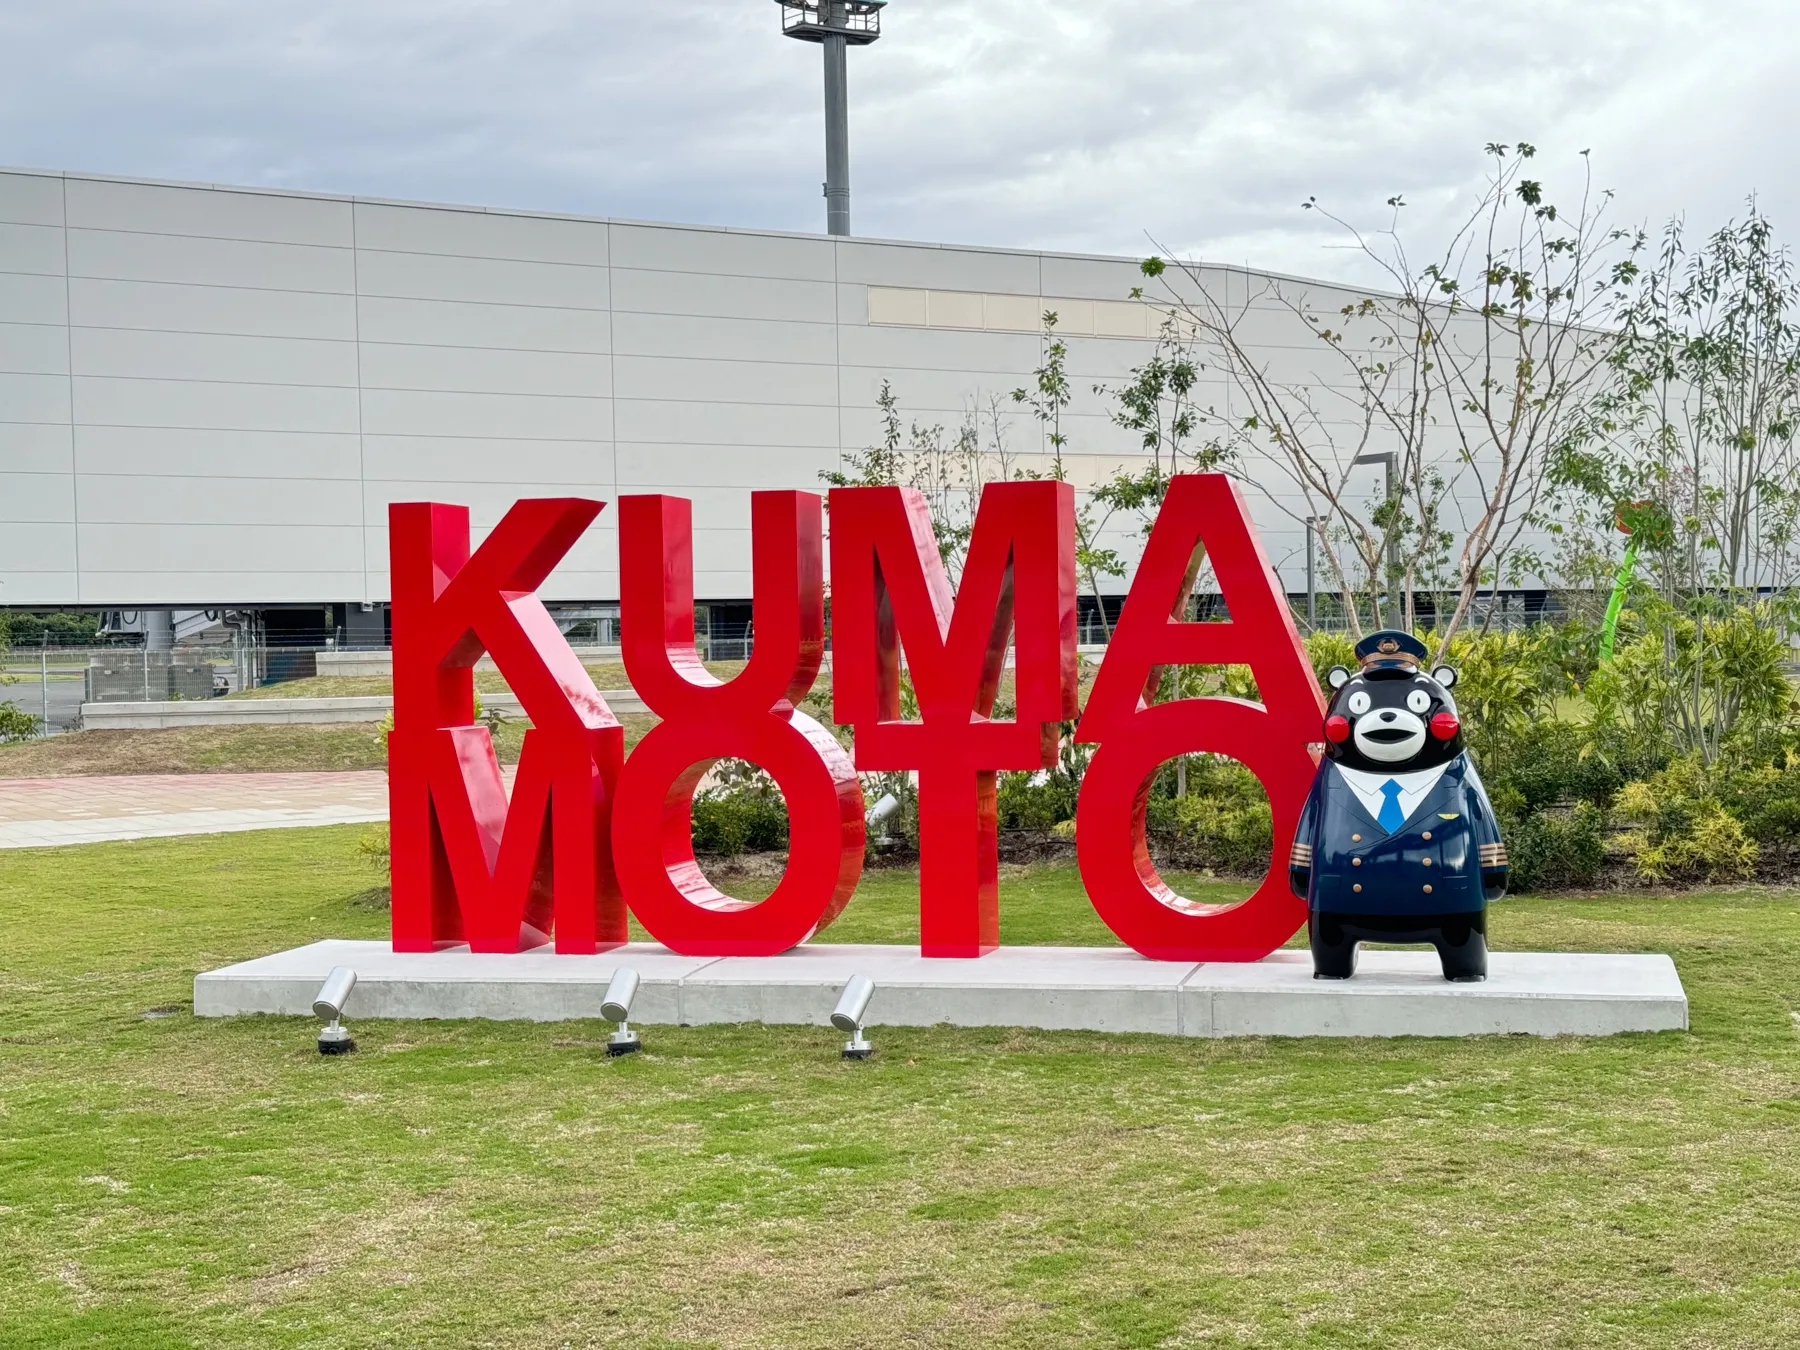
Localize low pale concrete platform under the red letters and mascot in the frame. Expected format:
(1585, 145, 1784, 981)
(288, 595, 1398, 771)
(194, 941, 1688, 1037)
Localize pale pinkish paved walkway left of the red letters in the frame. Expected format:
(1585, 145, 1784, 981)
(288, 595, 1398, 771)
(0, 770, 387, 848)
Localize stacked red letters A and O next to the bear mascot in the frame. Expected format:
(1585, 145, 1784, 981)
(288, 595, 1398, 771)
(1075, 473, 1325, 961)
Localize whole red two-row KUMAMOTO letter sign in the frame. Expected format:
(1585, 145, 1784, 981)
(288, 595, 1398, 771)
(389, 473, 1325, 961)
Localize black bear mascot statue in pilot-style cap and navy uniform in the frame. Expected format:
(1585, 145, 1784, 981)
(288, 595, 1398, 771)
(1287, 630, 1507, 981)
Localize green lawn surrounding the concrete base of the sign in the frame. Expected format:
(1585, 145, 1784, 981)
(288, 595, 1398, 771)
(0, 828, 1800, 1348)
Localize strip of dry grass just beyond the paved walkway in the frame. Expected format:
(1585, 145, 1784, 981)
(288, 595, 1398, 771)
(0, 715, 655, 779)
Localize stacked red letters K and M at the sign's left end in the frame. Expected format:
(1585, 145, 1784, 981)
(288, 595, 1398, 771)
(387, 497, 626, 952)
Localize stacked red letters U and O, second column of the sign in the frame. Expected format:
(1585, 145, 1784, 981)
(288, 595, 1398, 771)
(612, 491, 864, 956)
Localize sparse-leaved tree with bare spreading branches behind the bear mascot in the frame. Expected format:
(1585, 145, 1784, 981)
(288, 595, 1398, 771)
(1145, 144, 1643, 653)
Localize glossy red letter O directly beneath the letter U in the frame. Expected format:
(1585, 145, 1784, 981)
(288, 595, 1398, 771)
(612, 713, 864, 956)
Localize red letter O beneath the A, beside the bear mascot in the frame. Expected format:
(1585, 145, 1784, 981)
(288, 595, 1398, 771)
(1075, 698, 1316, 961)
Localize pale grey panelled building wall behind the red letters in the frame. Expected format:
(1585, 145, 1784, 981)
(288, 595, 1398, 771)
(0, 171, 1373, 607)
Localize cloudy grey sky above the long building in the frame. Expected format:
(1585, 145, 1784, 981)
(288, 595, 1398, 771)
(0, 0, 1800, 275)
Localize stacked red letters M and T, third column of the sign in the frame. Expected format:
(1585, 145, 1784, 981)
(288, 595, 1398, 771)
(832, 482, 1076, 956)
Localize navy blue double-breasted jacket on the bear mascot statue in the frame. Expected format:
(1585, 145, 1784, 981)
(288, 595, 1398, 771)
(1289, 751, 1507, 914)
